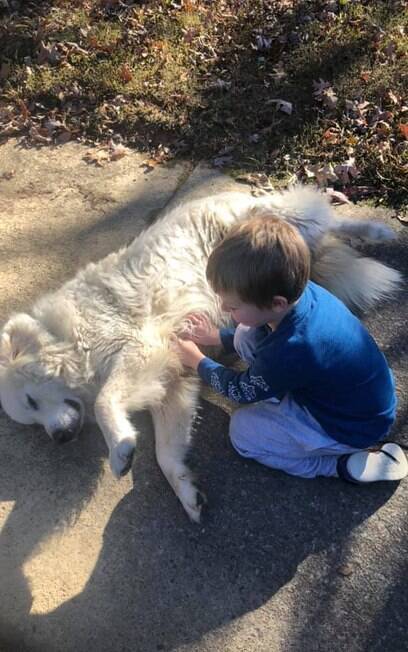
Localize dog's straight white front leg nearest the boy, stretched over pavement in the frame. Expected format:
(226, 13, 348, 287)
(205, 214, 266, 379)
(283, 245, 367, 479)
(151, 377, 205, 523)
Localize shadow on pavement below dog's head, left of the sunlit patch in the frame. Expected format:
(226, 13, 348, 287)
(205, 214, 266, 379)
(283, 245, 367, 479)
(0, 415, 106, 652)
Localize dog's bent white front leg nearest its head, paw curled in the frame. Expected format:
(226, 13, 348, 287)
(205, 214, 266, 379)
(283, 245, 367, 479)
(95, 375, 136, 478)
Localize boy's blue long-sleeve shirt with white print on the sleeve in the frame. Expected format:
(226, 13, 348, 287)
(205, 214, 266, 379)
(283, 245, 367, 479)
(198, 282, 397, 448)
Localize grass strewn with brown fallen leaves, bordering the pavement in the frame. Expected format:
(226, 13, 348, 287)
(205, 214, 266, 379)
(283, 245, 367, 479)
(0, 0, 408, 203)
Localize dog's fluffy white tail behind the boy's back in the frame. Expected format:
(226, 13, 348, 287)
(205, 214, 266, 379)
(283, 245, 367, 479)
(312, 237, 402, 312)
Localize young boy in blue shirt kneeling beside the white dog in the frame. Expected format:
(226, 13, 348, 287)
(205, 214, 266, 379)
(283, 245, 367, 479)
(175, 217, 408, 483)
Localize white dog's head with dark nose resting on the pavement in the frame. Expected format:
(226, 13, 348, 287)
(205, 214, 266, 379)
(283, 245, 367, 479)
(0, 314, 84, 443)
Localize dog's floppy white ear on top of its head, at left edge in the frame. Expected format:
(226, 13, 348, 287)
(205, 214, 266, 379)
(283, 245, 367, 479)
(0, 313, 41, 364)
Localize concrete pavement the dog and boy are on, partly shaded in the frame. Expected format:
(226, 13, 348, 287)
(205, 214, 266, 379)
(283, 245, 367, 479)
(0, 142, 408, 652)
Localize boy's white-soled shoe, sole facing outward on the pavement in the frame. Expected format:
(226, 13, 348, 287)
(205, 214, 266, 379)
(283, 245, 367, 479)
(346, 442, 408, 482)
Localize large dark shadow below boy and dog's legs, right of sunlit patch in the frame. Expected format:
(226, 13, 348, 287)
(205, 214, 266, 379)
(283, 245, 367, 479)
(15, 403, 396, 652)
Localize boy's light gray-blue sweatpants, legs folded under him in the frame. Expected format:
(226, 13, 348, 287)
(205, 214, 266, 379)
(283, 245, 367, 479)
(230, 324, 361, 478)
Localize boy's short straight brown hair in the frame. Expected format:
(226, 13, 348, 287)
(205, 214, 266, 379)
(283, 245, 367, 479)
(206, 215, 310, 308)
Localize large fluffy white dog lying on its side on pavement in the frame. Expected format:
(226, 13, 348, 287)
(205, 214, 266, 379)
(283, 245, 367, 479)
(0, 187, 400, 521)
